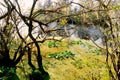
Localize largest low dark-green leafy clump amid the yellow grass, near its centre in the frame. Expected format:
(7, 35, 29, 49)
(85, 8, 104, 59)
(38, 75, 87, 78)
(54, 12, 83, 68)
(48, 51, 75, 60)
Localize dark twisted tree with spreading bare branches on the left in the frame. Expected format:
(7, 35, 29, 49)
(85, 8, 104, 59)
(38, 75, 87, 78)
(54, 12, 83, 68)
(0, 0, 73, 80)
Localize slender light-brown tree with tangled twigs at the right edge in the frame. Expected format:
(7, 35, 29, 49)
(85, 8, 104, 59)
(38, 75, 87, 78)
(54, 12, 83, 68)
(96, 0, 120, 80)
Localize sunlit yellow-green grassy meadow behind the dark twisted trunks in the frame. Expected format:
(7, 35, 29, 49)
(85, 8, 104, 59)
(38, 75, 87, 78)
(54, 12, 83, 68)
(17, 40, 110, 80)
